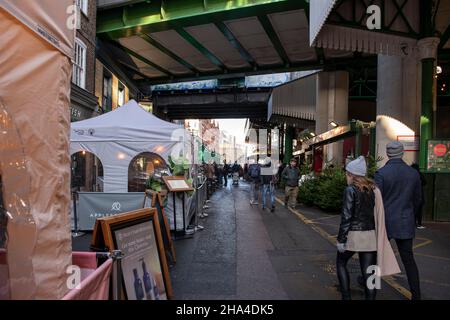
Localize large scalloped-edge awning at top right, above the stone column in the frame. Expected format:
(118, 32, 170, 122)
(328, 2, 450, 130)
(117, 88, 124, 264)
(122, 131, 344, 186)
(310, 0, 420, 56)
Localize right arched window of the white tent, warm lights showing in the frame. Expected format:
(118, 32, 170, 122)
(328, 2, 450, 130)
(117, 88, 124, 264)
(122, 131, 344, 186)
(128, 152, 167, 192)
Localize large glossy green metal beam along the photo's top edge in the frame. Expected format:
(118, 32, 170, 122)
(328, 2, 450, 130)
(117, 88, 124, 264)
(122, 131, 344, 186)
(97, 0, 308, 39)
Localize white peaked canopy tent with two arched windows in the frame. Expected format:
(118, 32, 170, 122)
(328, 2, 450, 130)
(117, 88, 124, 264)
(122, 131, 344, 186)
(70, 100, 190, 193)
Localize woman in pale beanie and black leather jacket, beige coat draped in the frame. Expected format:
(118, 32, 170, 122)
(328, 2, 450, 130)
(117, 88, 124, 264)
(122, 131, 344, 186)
(336, 156, 400, 300)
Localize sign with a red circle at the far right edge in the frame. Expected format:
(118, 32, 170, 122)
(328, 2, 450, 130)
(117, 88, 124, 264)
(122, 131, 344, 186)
(427, 140, 450, 173)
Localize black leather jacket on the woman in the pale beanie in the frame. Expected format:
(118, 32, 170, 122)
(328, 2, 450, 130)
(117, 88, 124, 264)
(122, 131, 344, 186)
(337, 186, 375, 243)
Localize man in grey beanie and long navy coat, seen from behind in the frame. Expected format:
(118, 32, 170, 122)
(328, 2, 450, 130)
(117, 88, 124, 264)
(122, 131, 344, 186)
(375, 141, 422, 300)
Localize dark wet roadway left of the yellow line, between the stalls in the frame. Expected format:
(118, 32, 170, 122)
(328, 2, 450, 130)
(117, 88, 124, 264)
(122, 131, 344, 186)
(172, 183, 405, 300)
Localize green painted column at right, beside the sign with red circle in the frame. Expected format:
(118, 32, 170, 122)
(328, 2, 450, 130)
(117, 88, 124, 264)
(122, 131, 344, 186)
(420, 58, 434, 171)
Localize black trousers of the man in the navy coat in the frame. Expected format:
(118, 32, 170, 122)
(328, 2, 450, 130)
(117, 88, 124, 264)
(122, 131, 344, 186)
(395, 239, 421, 300)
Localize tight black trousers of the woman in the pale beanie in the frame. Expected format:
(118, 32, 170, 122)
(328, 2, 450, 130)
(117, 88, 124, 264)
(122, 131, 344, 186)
(336, 251, 377, 300)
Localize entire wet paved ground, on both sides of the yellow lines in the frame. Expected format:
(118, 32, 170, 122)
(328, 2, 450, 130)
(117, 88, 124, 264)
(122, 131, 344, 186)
(73, 183, 450, 300)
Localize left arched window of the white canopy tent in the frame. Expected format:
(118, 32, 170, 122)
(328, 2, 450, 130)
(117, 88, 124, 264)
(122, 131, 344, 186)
(70, 151, 103, 192)
